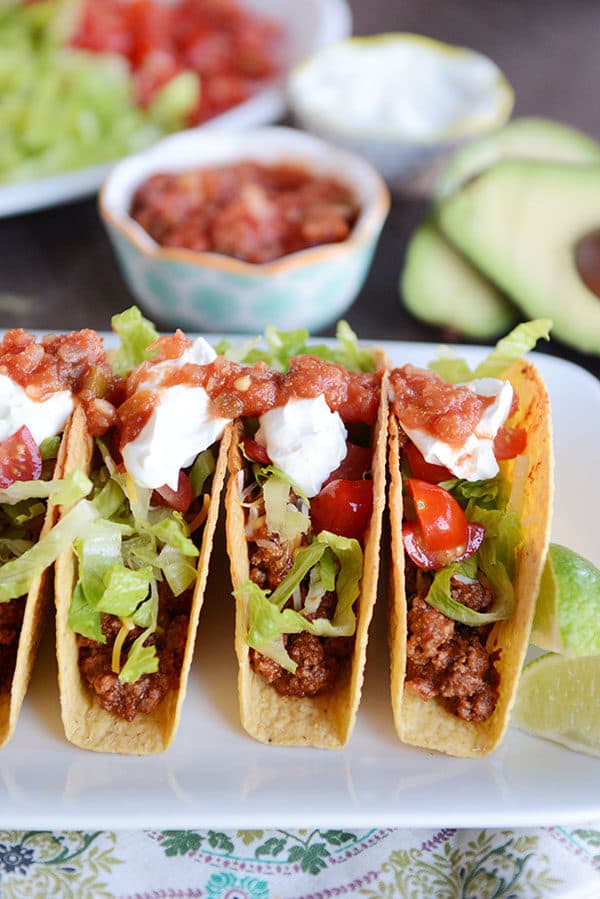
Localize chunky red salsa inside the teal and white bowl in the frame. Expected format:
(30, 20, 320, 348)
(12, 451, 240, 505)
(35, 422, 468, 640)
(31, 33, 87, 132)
(131, 162, 359, 264)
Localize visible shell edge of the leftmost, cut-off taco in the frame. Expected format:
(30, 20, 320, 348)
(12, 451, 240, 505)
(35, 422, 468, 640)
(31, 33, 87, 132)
(0, 418, 72, 747)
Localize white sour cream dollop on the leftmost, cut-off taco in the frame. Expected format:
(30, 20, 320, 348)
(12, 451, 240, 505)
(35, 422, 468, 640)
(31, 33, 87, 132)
(0, 375, 73, 444)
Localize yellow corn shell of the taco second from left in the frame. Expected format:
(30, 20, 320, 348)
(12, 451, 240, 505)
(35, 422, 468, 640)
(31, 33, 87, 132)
(55, 410, 231, 755)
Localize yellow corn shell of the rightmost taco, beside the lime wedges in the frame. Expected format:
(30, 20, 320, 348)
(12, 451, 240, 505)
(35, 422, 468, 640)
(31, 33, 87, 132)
(389, 362, 553, 757)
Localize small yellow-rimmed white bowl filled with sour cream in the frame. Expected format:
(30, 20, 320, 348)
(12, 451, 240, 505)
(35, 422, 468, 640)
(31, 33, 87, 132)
(288, 34, 514, 194)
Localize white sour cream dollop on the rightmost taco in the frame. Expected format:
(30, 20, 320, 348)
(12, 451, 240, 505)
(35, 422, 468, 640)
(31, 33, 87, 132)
(398, 378, 513, 481)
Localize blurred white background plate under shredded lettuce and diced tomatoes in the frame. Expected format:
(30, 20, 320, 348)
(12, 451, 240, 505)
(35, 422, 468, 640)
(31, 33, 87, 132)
(0, 0, 352, 218)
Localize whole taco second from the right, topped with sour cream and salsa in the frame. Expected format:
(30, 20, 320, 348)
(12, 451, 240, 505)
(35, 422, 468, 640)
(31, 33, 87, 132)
(226, 324, 387, 748)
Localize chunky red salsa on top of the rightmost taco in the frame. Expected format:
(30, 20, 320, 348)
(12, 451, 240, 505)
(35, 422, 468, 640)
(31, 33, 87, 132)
(390, 365, 494, 446)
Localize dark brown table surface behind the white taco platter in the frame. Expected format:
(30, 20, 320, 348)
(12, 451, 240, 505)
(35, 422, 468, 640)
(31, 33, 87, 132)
(0, 0, 600, 377)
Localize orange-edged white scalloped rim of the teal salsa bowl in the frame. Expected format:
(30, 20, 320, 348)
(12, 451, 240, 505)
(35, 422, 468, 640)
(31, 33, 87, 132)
(99, 126, 390, 277)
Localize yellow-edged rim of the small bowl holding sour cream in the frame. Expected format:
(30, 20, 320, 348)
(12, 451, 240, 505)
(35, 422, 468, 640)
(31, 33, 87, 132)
(286, 31, 515, 149)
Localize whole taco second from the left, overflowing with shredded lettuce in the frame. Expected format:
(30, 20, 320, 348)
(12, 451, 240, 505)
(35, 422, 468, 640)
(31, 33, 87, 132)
(55, 308, 230, 755)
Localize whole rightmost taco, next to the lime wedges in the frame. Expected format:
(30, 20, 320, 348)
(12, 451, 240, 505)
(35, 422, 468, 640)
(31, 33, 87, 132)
(389, 320, 553, 756)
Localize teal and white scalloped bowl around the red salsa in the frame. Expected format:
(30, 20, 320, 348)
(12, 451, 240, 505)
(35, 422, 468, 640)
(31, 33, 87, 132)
(100, 127, 390, 333)
